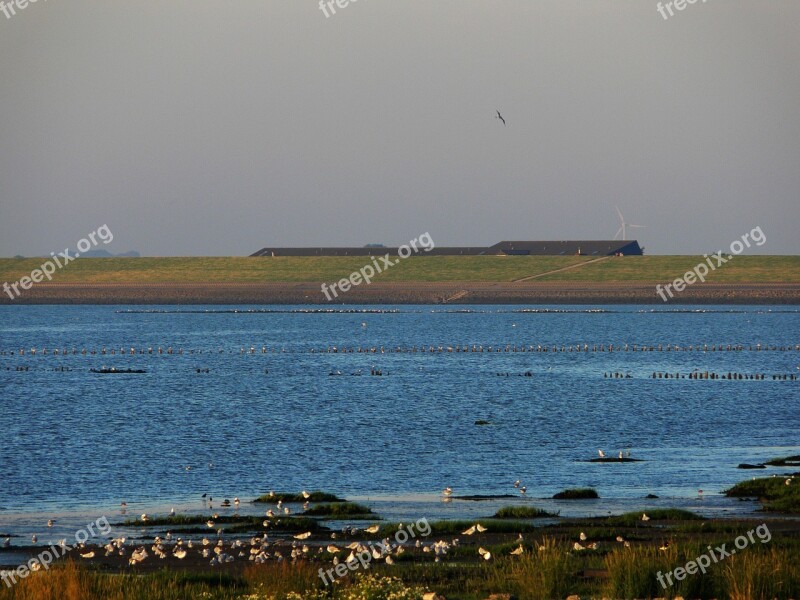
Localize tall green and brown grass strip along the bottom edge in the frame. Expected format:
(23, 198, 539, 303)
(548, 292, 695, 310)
(0, 537, 800, 600)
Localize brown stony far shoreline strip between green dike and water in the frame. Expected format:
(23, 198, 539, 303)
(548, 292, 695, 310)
(0, 282, 800, 306)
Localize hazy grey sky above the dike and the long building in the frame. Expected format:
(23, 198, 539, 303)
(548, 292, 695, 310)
(0, 0, 800, 256)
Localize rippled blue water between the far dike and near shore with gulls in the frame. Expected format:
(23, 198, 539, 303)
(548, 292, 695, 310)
(0, 306, 800, 531)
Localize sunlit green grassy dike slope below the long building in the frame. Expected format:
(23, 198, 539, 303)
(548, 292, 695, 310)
(0, 256, 800, 284)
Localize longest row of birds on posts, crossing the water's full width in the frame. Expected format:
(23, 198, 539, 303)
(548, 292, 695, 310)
(0, 344, 800, 356)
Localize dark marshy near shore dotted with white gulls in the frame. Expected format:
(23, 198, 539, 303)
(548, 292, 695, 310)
(0, 502, 800, 599)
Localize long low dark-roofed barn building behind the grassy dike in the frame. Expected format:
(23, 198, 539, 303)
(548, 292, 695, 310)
(250, 240, 644, 256)
